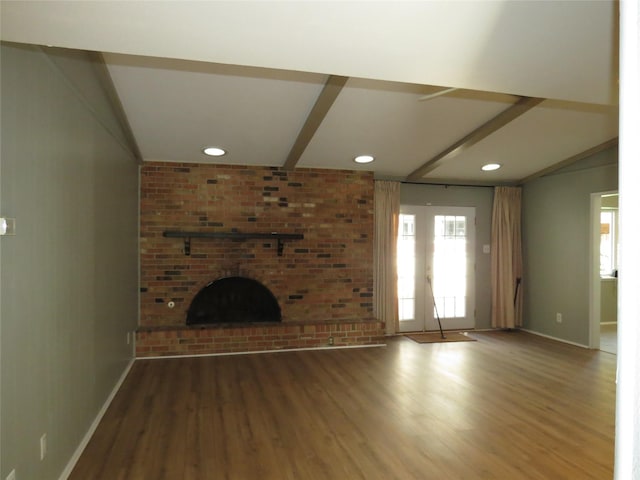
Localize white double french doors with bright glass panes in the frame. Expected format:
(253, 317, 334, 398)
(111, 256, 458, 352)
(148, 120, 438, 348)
(397, 205, 475, 332)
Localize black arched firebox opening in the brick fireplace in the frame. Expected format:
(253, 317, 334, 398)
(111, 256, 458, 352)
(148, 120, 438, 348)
(187, 277, 282, 325)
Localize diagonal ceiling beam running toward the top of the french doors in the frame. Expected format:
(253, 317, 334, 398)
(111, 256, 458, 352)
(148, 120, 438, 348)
(407, 97, 544, 181)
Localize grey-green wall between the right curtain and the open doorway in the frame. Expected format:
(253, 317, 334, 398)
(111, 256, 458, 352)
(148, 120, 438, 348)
(522, 148, 618, 346)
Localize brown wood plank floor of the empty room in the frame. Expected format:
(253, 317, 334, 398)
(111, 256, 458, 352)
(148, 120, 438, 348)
(70, 332, 616, 480)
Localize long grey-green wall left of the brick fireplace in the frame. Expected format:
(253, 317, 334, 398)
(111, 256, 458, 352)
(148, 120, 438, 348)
(0, 43, 138, 480)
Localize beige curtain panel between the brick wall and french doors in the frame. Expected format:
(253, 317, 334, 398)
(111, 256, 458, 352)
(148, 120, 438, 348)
(373, 180, 400, 335)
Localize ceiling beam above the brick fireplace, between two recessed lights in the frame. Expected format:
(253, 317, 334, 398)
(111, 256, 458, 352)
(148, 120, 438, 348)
(282, 75, 349, 170)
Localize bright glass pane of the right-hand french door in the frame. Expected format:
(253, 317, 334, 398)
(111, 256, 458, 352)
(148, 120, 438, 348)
(433, 215, 467, 318)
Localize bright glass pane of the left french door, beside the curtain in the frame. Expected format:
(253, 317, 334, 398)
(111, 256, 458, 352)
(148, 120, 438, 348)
(396, 214, 416, 321)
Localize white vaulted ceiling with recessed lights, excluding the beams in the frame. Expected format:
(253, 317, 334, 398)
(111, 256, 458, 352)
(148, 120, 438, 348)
(0, 0, 618, 184)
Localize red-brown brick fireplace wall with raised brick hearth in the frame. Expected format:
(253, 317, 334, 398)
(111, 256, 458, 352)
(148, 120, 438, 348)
(136, 162, 384, 357)
